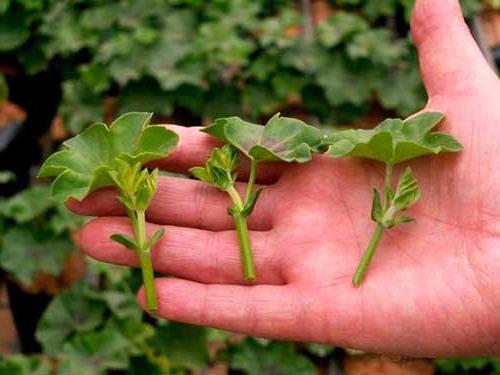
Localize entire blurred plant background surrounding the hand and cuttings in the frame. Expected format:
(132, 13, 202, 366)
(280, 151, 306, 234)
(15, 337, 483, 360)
(0, 0, 500, 375)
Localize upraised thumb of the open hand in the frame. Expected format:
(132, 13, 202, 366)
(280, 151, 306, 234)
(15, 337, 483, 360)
(411, 0, 497, 98)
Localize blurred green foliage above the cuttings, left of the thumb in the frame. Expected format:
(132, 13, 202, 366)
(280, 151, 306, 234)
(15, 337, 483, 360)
(0, 0, 496, 132)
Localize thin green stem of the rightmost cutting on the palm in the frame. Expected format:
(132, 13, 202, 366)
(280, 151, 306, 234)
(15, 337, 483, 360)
(352, 164, 393, 288)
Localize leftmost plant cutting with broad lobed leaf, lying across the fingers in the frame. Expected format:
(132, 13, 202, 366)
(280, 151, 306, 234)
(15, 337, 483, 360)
(39, 112, 178, 311)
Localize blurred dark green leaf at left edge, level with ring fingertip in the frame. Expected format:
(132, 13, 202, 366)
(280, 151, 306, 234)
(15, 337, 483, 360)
(0, 226, 75, 284)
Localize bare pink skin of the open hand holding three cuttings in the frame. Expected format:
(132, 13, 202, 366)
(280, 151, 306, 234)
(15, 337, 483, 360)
(69, 0, 500, 356)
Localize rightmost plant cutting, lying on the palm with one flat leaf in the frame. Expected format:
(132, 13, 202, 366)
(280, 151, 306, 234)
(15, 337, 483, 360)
(327, 112, 462, 287)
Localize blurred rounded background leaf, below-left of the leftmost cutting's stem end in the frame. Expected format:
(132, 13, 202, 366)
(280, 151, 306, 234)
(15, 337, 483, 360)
(36, 281, 106, 356)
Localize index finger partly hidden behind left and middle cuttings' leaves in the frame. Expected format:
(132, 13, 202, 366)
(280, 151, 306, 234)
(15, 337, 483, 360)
(150, 125, 287, 183)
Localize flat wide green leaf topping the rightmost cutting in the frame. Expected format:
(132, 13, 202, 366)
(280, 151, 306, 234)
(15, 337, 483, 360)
(327, 112, 462, 165)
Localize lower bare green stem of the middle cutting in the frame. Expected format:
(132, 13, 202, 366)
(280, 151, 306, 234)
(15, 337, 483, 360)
(226, 186, 256, 281)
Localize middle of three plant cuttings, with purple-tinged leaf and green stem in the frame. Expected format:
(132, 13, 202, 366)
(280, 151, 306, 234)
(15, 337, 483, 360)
(190, 114, 326, 281)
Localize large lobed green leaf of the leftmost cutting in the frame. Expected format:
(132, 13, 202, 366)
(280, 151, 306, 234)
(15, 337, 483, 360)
(40, 112, 178, 201)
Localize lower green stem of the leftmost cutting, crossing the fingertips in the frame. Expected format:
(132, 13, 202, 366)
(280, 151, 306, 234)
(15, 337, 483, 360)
(130, 211, 158, 312)
